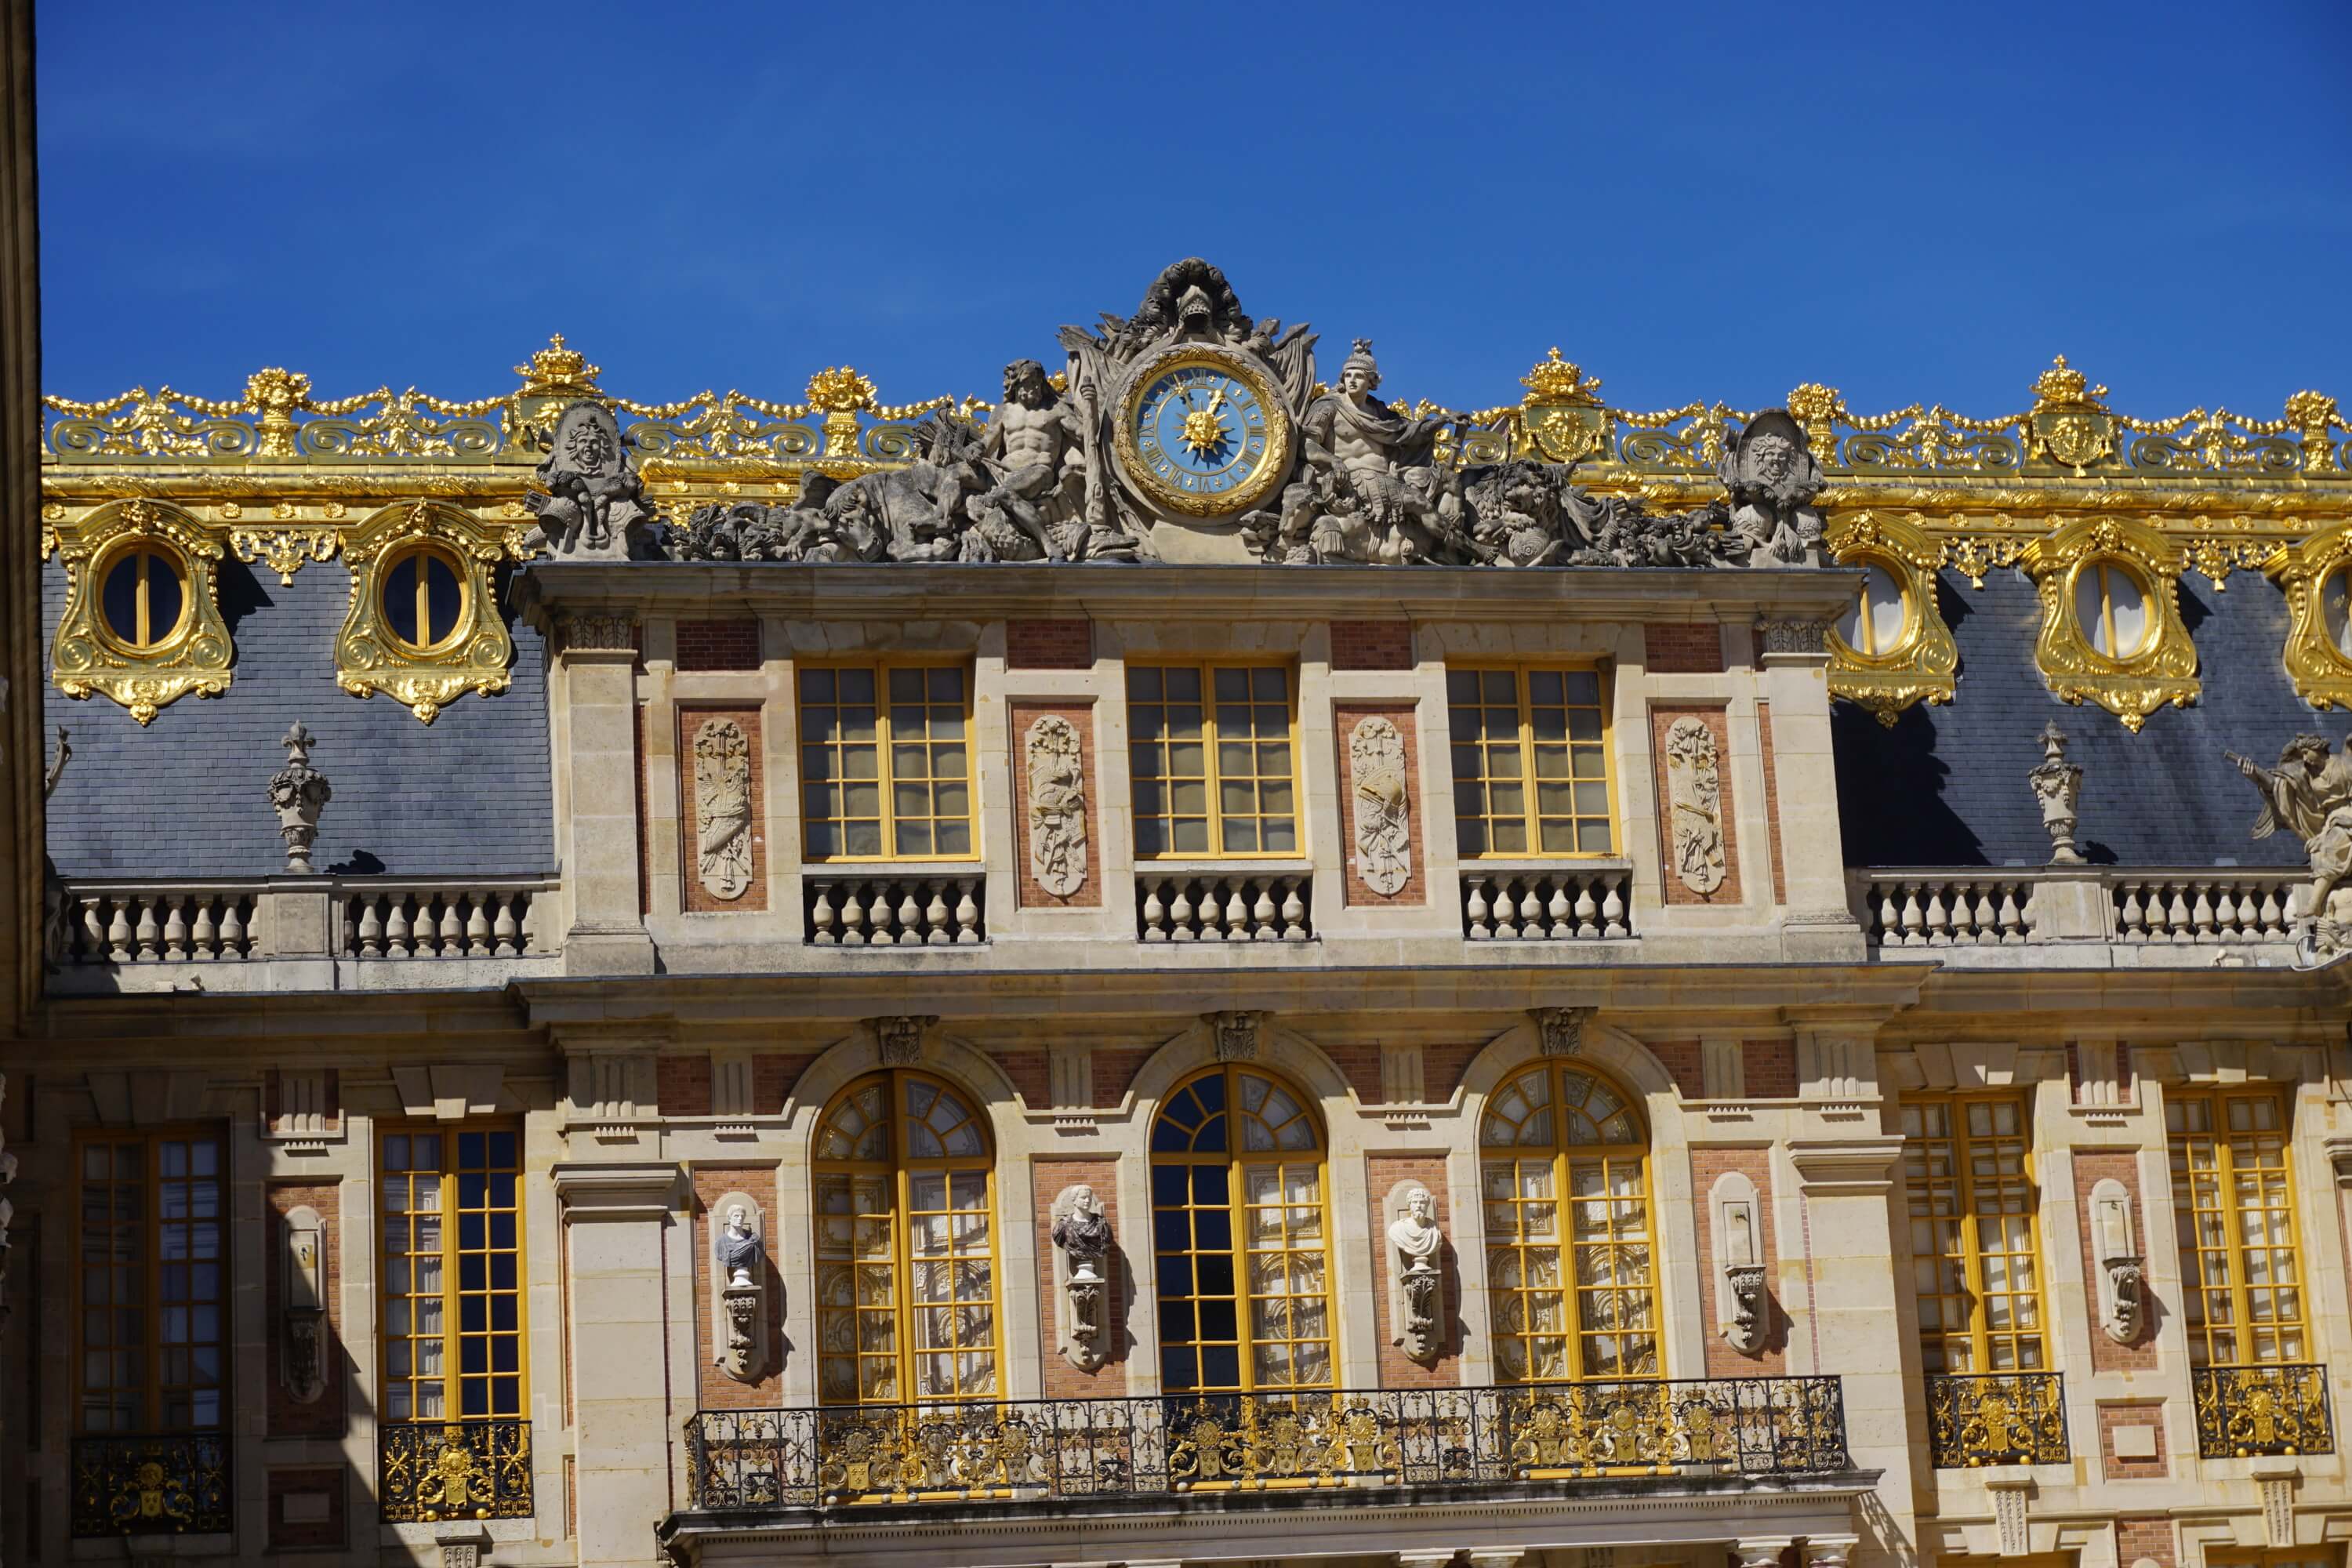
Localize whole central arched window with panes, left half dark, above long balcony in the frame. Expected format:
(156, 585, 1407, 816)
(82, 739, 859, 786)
(1152, 1065, 1331, 1394)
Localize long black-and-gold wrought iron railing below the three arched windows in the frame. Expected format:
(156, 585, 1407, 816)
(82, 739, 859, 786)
(687, 1377, 1851, 1509)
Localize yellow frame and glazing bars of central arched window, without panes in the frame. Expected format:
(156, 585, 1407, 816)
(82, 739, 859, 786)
(1145, 1062, 1338, 1394)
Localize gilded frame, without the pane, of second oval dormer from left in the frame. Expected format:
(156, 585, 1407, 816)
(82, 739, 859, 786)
(334, 501, 532, 724)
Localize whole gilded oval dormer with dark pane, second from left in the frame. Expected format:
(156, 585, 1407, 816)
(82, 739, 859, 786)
(334, 501, 529, 724)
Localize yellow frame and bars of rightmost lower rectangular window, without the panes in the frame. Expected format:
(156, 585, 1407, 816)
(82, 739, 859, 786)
(2164, 1083, 2319, 1366)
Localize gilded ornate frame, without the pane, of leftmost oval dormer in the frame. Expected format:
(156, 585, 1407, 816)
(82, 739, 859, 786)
(49, 499, 238, 729)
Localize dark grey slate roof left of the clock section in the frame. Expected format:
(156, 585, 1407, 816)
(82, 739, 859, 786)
(42, 557, 555, 877)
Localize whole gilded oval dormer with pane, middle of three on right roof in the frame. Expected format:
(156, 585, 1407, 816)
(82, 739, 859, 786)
(2018, 517, 2201, 731)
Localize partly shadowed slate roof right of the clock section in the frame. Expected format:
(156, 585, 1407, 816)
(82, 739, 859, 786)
(1832, 569, 2324, 867)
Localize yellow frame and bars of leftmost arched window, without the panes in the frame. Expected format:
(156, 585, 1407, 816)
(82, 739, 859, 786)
(809, 1067, 1004, 1410)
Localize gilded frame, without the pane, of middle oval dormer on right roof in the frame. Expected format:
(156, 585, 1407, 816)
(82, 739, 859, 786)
(2018, 517, 2204, 734)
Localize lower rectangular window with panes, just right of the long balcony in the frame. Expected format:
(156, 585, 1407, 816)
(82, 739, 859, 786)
(1903, 1095, 2046, 1373)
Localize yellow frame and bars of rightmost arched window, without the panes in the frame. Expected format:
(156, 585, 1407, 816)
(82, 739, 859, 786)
(1477, 1060, 1668, 1387)
